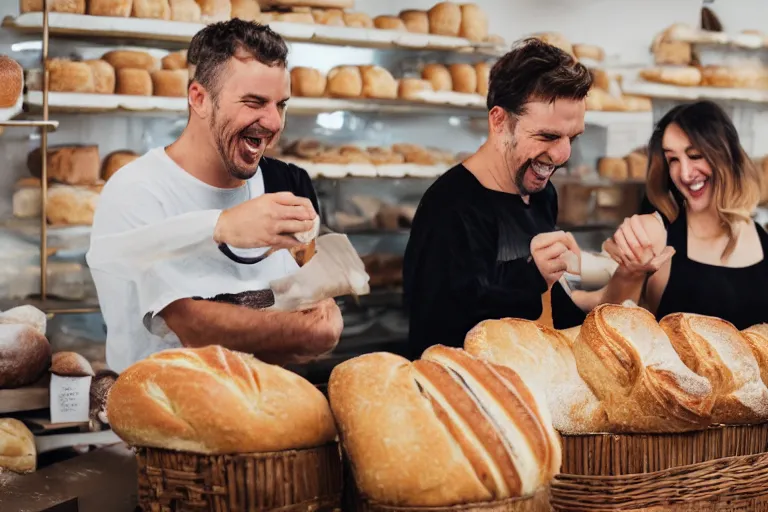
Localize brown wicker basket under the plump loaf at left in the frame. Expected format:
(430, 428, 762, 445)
(137, 443, 342, 512)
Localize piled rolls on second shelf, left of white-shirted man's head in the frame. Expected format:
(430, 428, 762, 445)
(39, 50, 189, 97)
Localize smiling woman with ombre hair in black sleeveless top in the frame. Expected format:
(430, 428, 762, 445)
(602, 101, 768, 329)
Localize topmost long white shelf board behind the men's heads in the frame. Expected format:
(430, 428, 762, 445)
(3, 12, 506, 56)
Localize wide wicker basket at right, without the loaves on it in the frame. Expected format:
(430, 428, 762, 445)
(550, 424, 768, 512)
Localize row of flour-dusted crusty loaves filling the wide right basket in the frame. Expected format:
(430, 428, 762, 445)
(466, 304, 768, 433)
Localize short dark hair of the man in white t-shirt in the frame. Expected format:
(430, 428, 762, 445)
(187, 18, 288, 97)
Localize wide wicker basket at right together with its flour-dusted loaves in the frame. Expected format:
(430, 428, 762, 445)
(465, 305, 768, 512)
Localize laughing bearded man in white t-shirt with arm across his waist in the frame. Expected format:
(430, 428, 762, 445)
(87, 19, 343, 372)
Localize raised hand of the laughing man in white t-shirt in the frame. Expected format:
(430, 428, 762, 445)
(213, 192, 317, 249)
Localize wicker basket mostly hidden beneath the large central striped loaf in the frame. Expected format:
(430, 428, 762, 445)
(343, 457, 552, 512)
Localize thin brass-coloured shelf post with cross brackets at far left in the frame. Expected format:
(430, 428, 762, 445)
(0, 0, 99, 315)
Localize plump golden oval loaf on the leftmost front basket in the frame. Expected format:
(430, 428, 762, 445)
(107, 345, 336, 454)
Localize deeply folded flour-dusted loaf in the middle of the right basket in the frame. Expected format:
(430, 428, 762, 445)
(573, 304, 715, 433)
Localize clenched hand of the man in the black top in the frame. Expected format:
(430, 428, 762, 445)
(531, 231, 581, 287)
